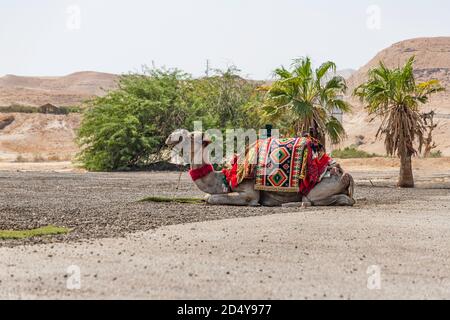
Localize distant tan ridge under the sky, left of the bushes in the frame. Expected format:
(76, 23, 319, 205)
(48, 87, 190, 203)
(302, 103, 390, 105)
(0, 72, 118, 106)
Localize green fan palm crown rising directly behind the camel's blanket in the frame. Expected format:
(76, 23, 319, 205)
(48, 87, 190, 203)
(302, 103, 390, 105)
(264, 57, 350, 145)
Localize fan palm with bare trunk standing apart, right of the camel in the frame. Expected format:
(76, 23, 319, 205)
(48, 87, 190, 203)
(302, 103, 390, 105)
(354, 57, 444, 188)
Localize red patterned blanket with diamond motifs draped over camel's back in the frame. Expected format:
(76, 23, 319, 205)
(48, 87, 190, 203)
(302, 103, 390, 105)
(223, 137, 331, 195)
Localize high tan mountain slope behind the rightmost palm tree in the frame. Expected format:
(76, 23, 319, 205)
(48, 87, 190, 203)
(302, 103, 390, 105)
(344, 37, 450, 156)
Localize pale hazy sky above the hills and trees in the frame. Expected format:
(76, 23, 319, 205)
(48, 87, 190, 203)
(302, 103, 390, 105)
(0, 0, 450, 79)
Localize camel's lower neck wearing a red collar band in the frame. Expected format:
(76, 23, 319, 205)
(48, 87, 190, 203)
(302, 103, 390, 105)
(191, 154, 228, 194)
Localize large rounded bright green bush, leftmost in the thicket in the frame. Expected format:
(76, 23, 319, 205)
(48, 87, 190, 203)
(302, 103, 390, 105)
(77, 70, 195, 171)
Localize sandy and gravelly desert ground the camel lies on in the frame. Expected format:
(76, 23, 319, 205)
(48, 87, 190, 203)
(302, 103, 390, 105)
(0, 158, 450, 299)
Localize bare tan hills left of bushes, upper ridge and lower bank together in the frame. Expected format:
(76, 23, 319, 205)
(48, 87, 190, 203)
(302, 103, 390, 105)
(0, 72, 118, 161)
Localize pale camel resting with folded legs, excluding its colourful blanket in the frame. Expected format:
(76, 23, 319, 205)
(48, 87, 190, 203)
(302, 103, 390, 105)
(166, 129, 355, 207)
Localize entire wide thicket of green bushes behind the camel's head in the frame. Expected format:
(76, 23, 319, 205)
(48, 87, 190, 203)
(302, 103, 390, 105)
(77, 68, 262, 171)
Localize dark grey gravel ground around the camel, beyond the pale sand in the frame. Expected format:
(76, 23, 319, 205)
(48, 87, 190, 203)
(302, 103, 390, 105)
(0, 172, 449, 246)
